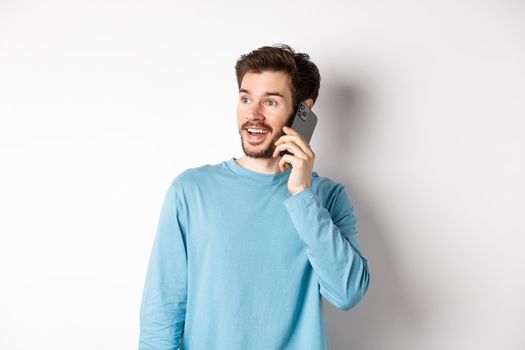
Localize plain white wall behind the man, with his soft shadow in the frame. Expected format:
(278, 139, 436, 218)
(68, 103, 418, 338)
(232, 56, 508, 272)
(0, 0, 525, 350)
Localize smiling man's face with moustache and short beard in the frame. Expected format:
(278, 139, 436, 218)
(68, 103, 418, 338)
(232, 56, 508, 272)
(237, 71, 293, 158)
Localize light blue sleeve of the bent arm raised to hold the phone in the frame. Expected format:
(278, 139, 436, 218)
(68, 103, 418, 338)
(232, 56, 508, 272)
(284, 184, 370, 310)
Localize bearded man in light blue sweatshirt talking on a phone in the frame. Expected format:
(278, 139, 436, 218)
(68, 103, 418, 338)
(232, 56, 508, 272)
(139, 45, 369, 350)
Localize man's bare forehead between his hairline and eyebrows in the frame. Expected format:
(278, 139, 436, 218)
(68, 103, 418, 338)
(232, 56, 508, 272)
(241, 71, 292, 98)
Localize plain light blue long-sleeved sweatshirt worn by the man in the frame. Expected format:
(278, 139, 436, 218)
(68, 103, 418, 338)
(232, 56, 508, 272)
(139, 158, 370, 350)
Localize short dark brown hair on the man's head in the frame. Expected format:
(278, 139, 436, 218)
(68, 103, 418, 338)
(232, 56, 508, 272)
(235, 44, 321, 107)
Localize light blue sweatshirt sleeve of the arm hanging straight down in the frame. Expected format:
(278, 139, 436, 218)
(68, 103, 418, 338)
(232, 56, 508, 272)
(139, 183, 187, 350)
